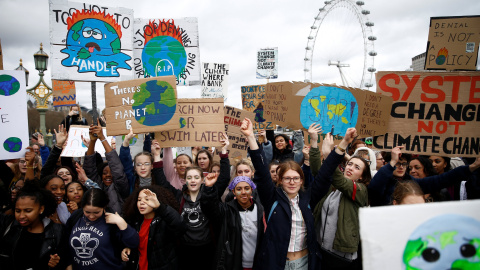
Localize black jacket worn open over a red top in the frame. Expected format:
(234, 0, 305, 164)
(127, 204, 186, 270)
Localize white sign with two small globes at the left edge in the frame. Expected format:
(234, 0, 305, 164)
(0, 70, 29, 160)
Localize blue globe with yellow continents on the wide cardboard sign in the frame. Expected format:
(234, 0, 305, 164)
(300, 86, 358, 136)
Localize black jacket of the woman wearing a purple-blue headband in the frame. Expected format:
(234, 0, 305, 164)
(200, 186, 265, 270)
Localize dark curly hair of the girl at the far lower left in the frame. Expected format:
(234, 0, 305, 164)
(14, 179, 57, 220)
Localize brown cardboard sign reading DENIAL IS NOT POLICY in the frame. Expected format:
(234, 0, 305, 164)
(425, 16, 480, 70)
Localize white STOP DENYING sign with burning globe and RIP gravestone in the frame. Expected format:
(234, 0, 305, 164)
(133, 18, 200, 86)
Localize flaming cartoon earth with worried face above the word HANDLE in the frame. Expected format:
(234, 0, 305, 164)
(61, 10, 132, 77)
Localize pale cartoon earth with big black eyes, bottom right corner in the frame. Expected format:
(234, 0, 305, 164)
(403, 214, 480, 270)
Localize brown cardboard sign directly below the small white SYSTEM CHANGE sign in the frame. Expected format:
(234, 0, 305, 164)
(242, 84, 275, 130)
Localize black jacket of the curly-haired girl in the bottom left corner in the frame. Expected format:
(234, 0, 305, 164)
(0, 214, 68, 269)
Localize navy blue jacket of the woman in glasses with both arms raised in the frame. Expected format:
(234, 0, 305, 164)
(249, 150, 343, 270)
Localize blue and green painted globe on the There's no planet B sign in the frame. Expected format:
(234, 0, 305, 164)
(132, 80, 177, 126)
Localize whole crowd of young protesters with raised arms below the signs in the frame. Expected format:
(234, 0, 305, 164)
(0, 109, 480, 270)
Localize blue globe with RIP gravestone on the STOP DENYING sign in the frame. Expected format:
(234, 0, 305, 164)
(142, 36, 187, 77)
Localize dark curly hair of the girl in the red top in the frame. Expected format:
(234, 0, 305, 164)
(123, 185, 180, 223)
